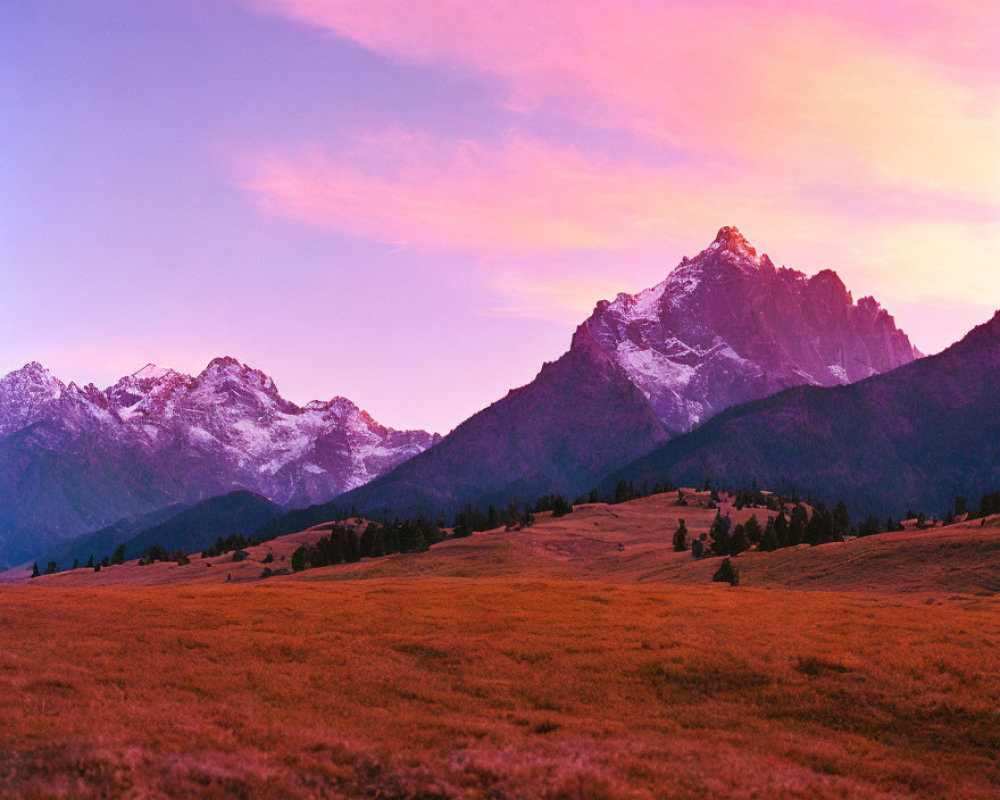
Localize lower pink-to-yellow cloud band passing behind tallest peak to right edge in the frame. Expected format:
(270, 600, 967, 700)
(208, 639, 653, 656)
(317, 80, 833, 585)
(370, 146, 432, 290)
(242, 128, 1000, 332)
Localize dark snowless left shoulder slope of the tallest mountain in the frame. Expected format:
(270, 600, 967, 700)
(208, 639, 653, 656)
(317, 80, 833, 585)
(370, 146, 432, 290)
(276, 349, 667, 516)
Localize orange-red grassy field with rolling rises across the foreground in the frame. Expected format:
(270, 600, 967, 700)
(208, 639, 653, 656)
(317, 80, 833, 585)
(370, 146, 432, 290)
(0, 498, 1000, 800)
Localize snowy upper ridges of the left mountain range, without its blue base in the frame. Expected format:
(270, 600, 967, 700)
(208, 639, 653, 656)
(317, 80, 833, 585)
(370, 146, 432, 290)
(0, 357, 438, 505)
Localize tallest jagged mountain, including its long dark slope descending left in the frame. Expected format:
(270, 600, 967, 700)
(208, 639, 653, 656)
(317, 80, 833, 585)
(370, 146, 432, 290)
(324, 227, 920, 514)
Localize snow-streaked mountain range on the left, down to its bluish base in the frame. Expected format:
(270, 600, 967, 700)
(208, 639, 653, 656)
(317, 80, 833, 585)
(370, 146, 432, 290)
(0, 358, 436, 564)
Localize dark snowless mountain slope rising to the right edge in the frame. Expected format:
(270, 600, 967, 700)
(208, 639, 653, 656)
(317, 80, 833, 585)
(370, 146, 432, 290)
(603, 312, 1000, 515)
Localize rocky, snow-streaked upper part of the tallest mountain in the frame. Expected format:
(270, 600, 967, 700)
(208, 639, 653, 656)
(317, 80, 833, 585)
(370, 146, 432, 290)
(573, 226, 920, 433)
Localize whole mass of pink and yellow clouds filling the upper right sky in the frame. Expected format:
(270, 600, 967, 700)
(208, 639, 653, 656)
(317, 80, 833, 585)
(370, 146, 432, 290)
(236, 0, 1000, 330)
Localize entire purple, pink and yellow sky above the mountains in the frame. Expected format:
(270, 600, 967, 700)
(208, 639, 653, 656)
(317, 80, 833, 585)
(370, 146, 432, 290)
(0, 0, 1000, 431)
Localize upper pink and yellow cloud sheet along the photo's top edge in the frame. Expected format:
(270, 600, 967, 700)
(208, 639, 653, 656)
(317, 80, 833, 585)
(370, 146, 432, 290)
(248, 0, 1000, 202)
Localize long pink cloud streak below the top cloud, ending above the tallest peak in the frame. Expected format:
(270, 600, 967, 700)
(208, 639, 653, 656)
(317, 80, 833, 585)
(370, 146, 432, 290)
(242, 128, 788, 255)
